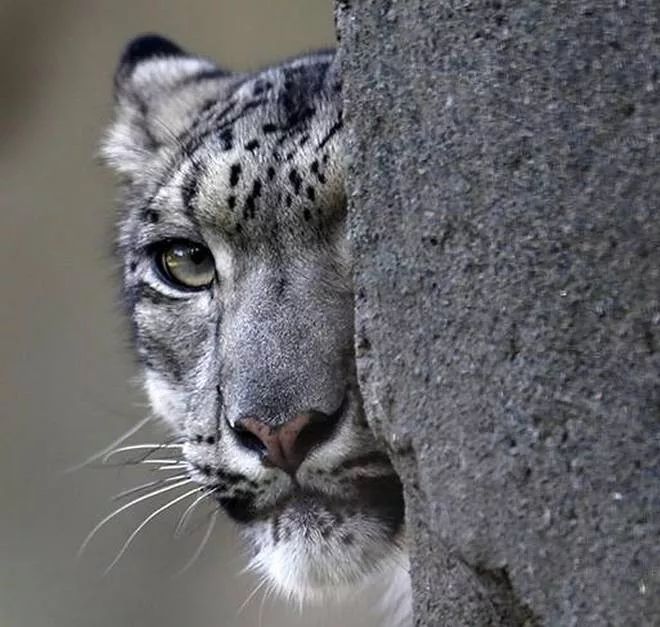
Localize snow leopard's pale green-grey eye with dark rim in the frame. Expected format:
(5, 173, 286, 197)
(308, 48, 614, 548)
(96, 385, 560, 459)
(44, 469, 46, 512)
(154, 240, 215, 290)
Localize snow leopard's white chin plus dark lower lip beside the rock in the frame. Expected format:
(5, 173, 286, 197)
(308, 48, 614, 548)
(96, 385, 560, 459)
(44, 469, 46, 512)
(215, 474, 405, 604)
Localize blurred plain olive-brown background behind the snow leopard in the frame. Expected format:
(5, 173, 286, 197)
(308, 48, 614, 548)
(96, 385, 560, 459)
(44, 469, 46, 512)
(0, 0, 378, 627)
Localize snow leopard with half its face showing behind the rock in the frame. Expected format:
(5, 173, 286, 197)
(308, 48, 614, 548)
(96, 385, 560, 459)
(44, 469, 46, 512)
(102, 35, 405, 624)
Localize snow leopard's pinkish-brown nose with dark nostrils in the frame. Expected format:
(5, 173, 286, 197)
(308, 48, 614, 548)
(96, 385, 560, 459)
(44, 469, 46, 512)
(232, 404, 343, 476)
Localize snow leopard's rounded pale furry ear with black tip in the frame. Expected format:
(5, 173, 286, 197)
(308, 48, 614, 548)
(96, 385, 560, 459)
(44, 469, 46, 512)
(101, 34, 230, 180)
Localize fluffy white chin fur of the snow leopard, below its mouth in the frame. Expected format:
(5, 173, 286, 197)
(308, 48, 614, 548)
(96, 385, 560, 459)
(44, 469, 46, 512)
(244, 486, 405, 605)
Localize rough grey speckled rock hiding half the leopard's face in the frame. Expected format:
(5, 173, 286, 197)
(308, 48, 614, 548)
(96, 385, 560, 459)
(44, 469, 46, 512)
(337, 0, 660, 627)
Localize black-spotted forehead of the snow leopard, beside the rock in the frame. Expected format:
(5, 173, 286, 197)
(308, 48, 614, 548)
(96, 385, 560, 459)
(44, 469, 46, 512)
(191, 64, 344, 238)
